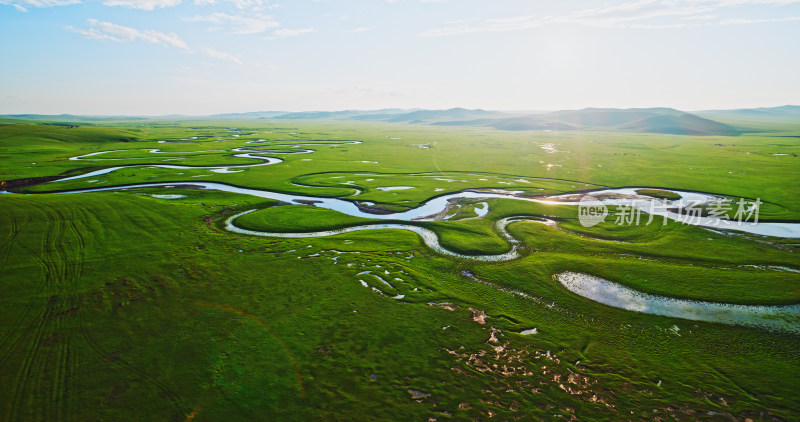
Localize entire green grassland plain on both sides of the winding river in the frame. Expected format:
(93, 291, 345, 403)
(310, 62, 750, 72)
(0, 120, 800, 421)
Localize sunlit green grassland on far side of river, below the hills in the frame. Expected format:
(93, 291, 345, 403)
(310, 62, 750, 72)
(7, 121, 800, 219)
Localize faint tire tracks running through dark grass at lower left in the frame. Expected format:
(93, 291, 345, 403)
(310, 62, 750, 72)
(0, 204, 167, 421)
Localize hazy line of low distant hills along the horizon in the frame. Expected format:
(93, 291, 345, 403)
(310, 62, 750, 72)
(0, 105, 784, 136)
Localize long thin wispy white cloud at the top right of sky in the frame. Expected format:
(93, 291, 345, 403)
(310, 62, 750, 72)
(420, 0, 800, 37)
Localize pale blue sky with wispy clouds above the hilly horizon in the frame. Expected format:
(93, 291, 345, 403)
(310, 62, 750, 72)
(0, 0, 800, 115)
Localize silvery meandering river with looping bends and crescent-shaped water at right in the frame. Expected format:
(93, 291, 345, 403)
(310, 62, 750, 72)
(3, 145, 800, 333)
